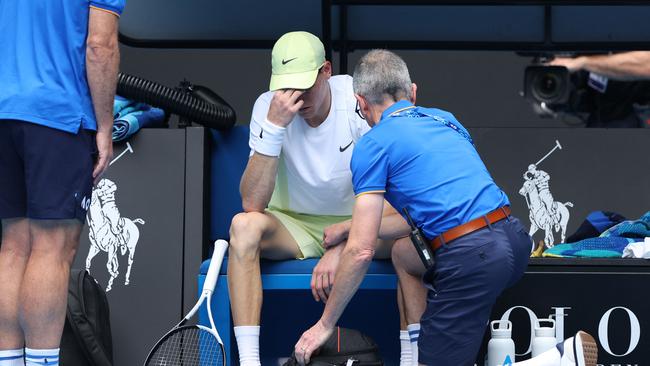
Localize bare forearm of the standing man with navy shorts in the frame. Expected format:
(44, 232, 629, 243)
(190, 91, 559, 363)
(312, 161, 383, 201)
(86, 35, 120, 133)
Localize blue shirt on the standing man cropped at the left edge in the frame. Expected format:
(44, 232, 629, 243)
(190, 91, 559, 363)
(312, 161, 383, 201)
(0, 0, 125, 133)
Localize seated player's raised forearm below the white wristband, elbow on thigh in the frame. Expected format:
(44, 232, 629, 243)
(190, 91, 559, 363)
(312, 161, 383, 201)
(239, 153, 278, 212)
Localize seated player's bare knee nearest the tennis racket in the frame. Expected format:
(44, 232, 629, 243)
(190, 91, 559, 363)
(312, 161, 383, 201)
(230, 212, 268, 252)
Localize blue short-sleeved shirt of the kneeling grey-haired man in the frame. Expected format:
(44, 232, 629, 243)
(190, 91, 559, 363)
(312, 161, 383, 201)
(350, 100, 509, 239)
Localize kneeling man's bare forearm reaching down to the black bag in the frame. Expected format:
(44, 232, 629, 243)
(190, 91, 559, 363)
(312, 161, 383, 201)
(321, 239, 376, 328)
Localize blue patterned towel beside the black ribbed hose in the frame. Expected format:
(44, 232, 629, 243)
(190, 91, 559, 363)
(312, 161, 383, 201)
(113, 95, 165, 141)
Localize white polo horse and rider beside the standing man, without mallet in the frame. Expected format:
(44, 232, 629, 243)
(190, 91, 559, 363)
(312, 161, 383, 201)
(86, 179, 145, 292)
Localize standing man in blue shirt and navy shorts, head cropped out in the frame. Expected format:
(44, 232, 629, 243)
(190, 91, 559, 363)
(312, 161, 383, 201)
(0, 0, 124, 366)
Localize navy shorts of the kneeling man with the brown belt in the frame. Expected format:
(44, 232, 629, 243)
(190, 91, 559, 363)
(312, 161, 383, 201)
(418, 216, 532, 366)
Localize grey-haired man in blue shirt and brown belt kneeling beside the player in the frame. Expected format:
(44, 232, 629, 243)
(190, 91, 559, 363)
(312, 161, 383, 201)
(295, 50, 596, 366)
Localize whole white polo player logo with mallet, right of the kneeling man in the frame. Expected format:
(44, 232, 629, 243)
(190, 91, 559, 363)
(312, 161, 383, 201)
(519, 140, 573, 248)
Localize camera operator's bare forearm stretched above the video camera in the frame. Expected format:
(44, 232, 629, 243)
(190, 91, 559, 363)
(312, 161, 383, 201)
(582, 51, 650, 80)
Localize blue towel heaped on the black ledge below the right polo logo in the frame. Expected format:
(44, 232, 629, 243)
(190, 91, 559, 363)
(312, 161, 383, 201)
(542, 211, 650, 258)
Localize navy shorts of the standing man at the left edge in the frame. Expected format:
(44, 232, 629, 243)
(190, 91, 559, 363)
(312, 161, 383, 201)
(0, 120, 97, 222)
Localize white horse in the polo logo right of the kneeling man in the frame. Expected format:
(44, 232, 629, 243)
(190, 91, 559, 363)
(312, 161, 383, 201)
(519, 179, 573, 248)
